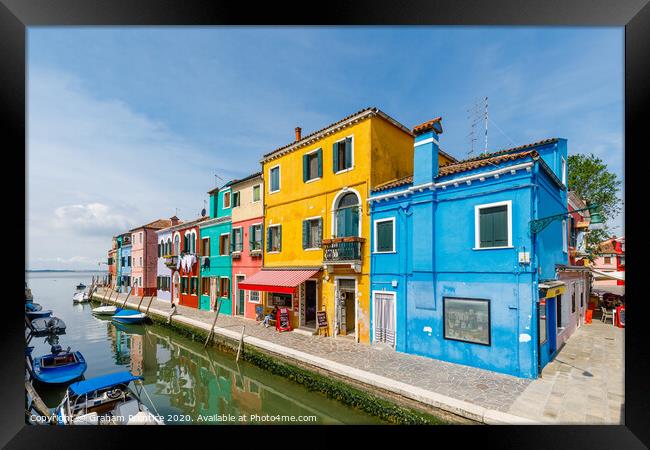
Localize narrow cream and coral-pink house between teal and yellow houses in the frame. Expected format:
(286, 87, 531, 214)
(230, 173, 264, 319)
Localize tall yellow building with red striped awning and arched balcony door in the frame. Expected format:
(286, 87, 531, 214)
(240, 108, 454, 342)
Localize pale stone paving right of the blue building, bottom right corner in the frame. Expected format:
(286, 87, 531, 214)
(508, 320, 625, 425)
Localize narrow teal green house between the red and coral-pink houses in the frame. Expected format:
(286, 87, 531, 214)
(199, 182, 233, 315)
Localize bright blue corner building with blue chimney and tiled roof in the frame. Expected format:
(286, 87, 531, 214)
(369, 118, 568, 378)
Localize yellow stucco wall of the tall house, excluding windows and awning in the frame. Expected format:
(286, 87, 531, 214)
(263, 112, 413, 342)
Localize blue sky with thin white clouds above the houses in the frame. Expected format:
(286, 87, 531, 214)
(26, 27, 624, 269)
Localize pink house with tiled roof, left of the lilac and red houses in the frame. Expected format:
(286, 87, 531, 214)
(130, 219, 172, 296)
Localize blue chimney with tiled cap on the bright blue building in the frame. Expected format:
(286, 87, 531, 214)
(413, 117, 442, 186)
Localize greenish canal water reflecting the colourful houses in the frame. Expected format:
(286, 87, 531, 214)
(26, 272, 384, 425)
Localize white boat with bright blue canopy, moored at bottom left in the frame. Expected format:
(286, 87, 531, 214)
(54, 371, 165, 425)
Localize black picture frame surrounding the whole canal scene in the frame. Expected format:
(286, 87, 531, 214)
(0, 0, 650, 449)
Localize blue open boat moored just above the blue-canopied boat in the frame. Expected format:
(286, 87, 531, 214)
(28, 344, 88, 384)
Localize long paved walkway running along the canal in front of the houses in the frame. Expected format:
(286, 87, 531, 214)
(93, 295, 623, 423)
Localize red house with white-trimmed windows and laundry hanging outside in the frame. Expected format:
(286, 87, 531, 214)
(166, 217, 209, 308)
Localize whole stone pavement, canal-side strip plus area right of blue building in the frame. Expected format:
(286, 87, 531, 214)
(93, 294, 623, 423)
